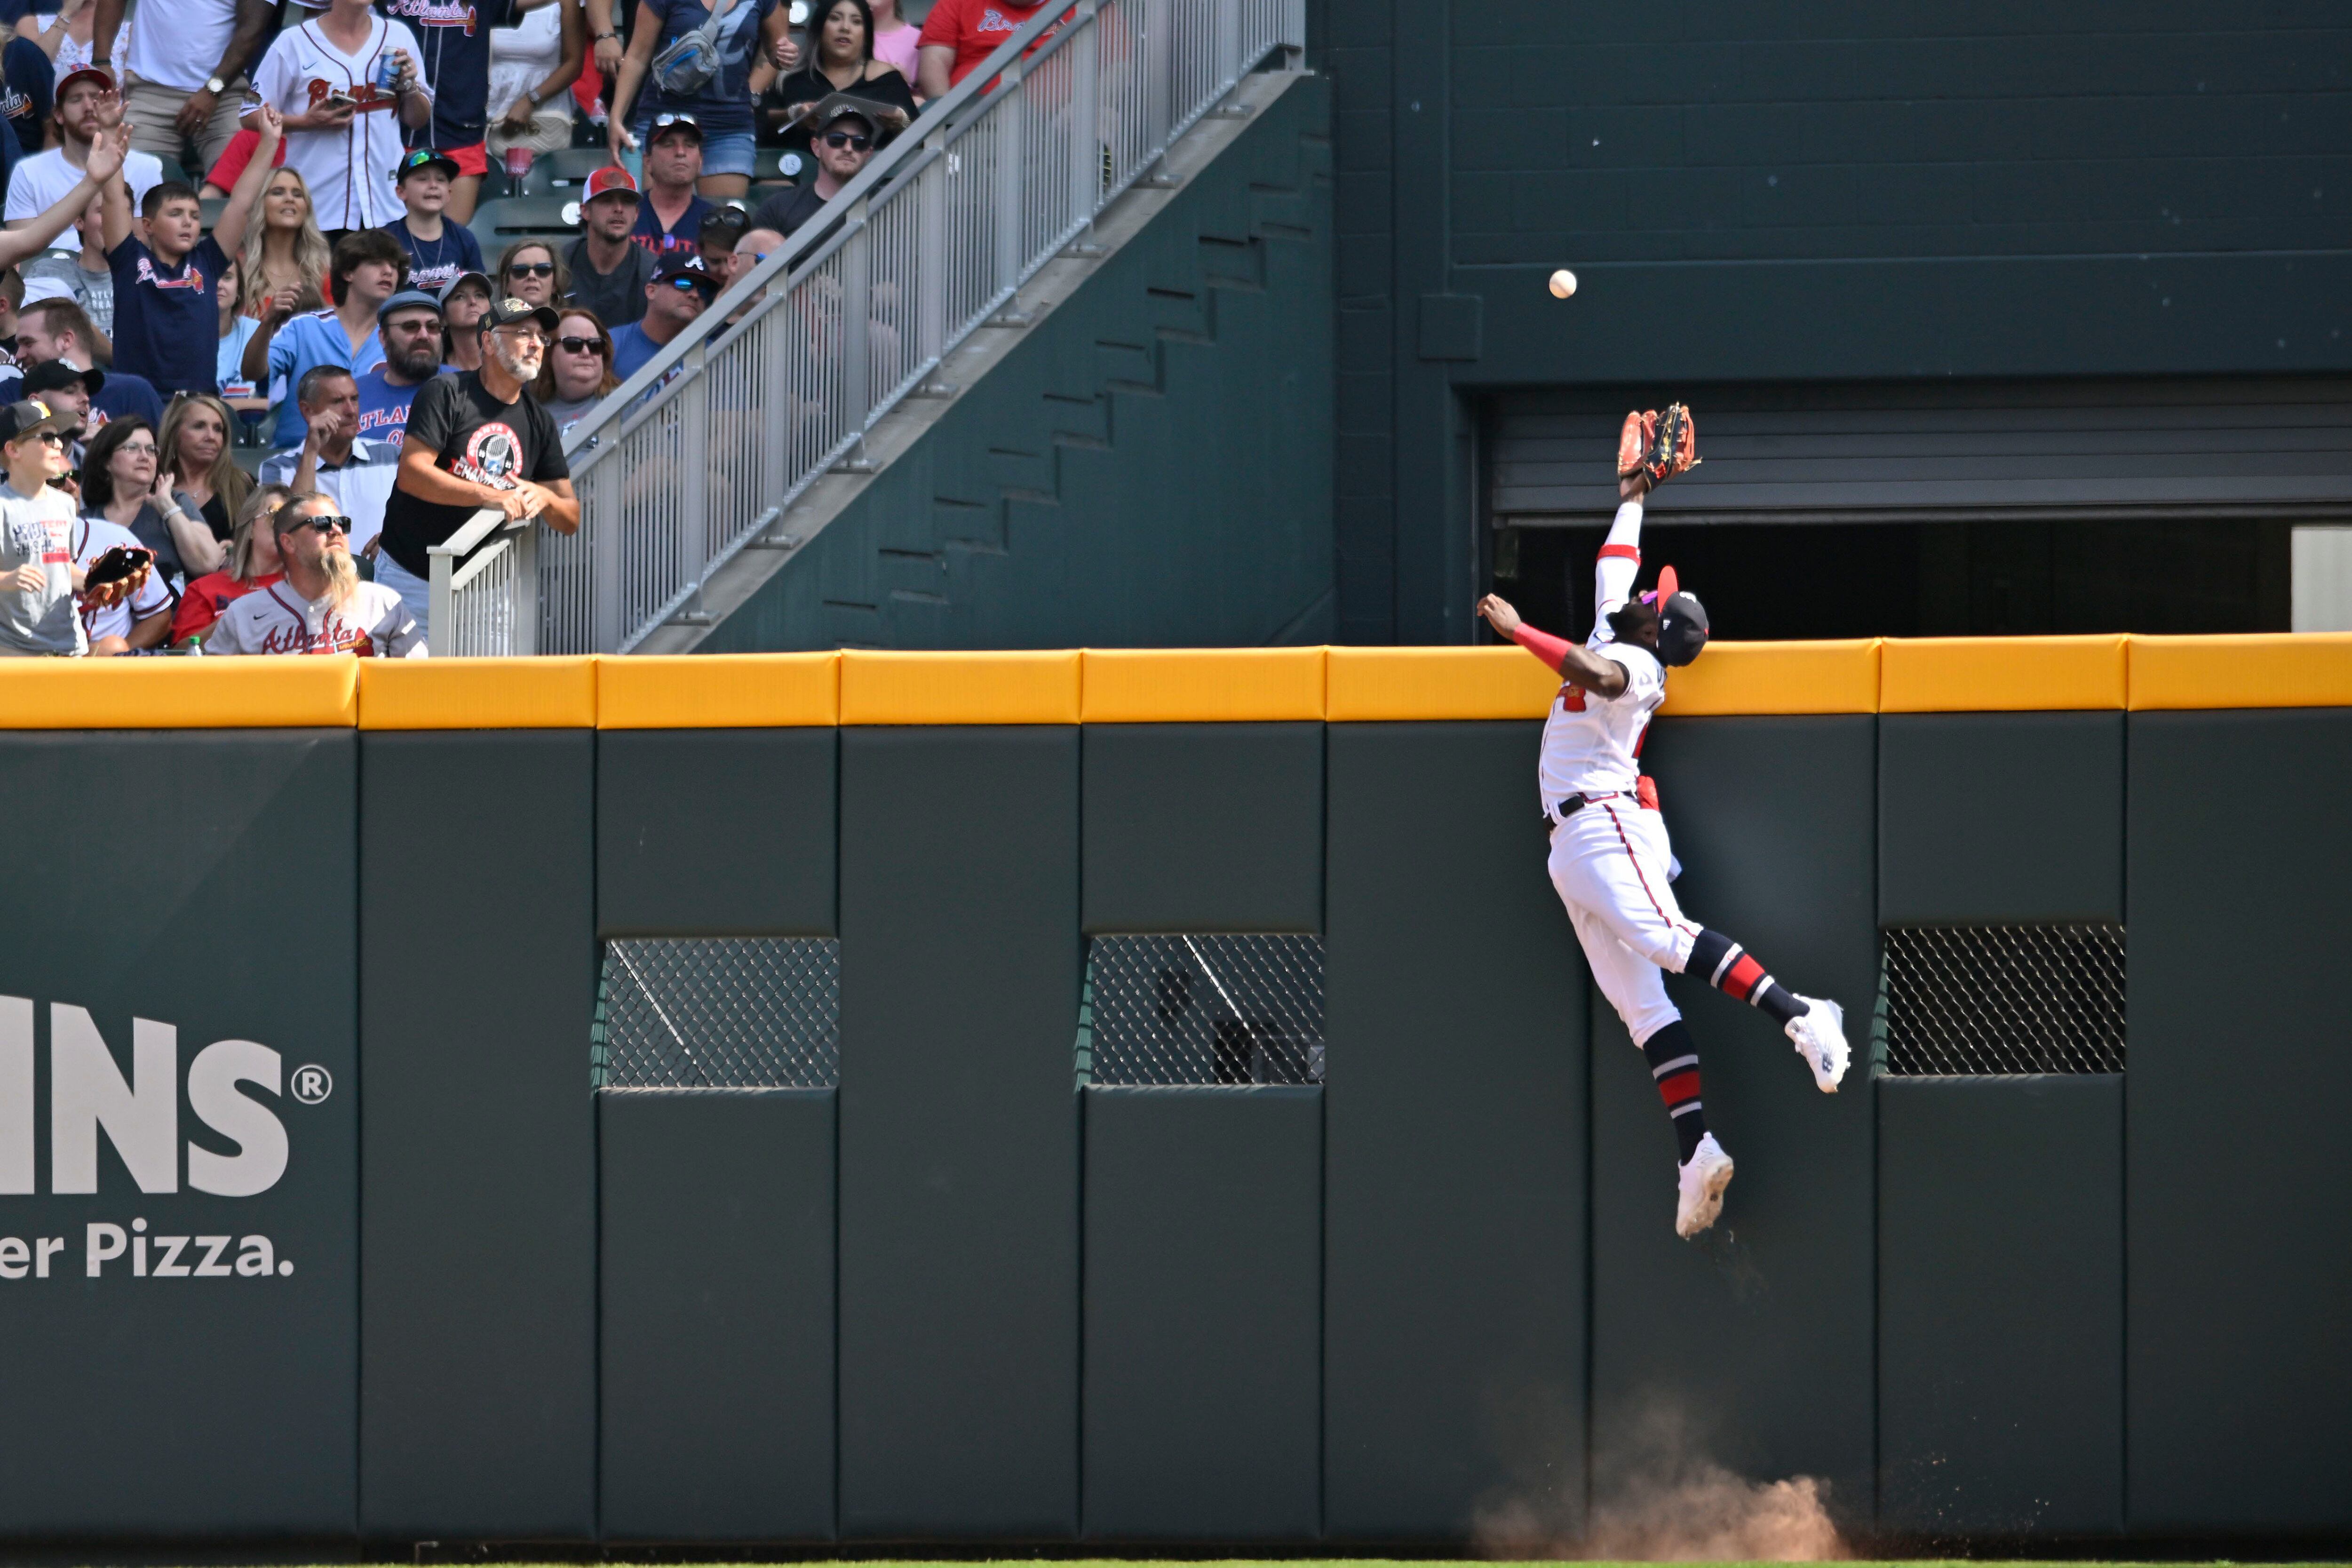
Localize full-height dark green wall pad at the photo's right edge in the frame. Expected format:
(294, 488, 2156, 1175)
(2124, 708, 2352, 1537)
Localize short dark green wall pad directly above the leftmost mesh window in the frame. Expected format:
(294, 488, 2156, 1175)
(595, 726, 840, 936)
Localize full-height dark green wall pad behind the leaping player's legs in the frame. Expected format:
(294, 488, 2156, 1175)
(1592, 717, 1877, 1521)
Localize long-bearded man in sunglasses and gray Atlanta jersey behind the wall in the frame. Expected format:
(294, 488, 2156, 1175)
(205, 491, 426, 658)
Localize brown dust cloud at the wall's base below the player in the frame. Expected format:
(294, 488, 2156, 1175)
(1475, 1403, 1849, 1563)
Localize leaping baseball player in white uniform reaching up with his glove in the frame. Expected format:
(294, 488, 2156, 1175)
(1477, 402, 1849, 1239)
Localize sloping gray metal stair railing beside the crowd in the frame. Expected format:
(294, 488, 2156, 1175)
(433, 0, 1305, 653)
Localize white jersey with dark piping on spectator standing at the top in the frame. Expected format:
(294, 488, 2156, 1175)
(248, 16, 430, 231)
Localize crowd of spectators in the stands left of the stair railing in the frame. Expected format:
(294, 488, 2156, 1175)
(0, 0, 1068, 656)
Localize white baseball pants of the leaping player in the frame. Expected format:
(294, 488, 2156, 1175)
(1545, 795, 1698, 1046)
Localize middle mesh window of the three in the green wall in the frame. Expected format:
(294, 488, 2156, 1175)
(1077, 936, 1324, 1084)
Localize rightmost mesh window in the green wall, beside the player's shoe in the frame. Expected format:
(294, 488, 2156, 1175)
(1872, 926, 2124, 1077)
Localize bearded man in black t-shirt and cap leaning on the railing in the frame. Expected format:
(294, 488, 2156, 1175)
(376, 299, 581, 630)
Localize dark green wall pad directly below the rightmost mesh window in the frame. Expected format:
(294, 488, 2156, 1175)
(1879, 1075, 2124, 1537)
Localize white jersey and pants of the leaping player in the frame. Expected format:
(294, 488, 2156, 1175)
(1538, 501, 1700, 1046)
